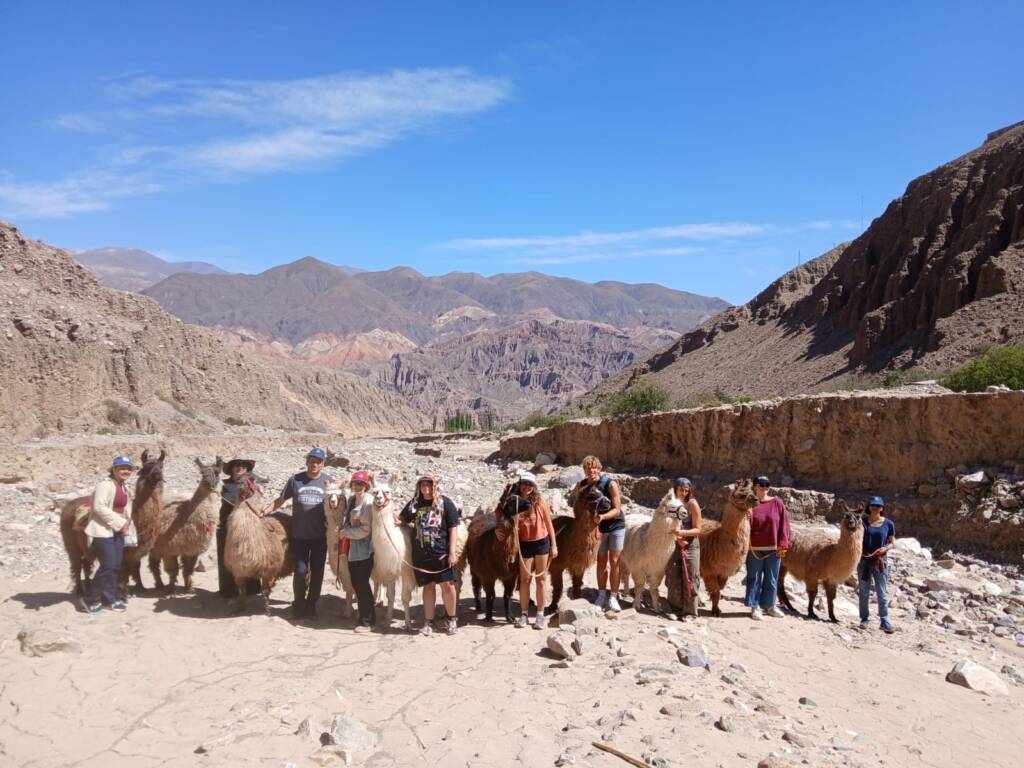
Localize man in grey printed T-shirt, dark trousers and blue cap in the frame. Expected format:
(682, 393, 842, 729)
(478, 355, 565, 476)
(271, 447, 333, 620)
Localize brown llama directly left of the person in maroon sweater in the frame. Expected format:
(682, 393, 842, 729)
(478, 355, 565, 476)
(699, 479, 758, 616)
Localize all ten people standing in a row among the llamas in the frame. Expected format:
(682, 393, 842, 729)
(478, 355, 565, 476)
(79, 447, 896, 635)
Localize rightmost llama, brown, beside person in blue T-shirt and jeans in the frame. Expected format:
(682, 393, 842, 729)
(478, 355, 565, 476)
(778, 510, 864, 622)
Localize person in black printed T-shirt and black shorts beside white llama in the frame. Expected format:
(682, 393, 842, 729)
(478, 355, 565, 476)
(398, 476, 459, 635)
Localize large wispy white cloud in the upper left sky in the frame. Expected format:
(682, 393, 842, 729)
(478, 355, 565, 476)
(0, 68, 512, 217)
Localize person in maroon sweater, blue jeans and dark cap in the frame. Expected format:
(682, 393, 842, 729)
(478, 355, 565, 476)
(745, 475, 792, 621)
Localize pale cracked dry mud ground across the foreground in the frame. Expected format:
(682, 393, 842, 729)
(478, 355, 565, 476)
(0, 440, 1024, 768)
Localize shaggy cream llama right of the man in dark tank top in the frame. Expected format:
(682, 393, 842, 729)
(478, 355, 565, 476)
(618, 490, 686, 613)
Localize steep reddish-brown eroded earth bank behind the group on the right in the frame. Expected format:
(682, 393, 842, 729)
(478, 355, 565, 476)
(501, 387, 1024, 561)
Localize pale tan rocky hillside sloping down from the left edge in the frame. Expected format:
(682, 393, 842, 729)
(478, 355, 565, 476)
(0, 223, 423, 439)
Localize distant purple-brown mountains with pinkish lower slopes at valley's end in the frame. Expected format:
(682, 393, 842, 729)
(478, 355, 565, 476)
(138, 258, 727, 423)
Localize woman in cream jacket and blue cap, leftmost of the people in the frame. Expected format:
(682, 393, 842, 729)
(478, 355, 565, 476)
(85, 456, 135, 613)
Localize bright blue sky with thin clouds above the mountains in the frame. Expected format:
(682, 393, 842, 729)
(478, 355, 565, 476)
(0, 0, 1024, 302)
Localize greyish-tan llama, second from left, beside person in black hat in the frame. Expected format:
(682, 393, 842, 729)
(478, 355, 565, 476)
(150, 456, 224, 595)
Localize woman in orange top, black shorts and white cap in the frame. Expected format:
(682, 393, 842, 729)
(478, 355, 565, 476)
(495, 472, 558, 630)
